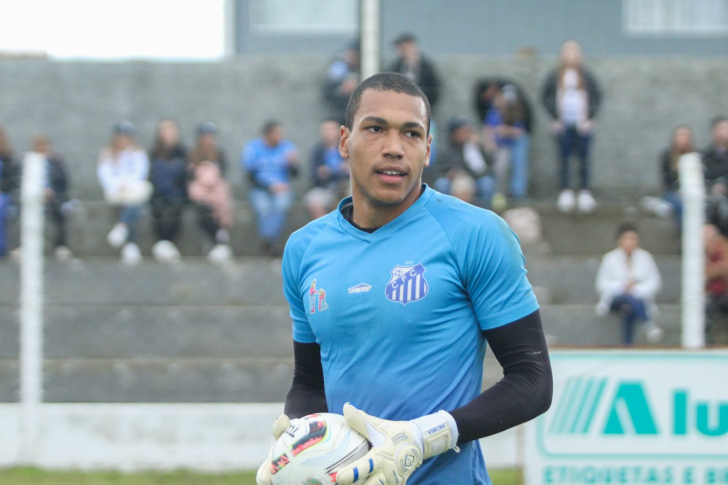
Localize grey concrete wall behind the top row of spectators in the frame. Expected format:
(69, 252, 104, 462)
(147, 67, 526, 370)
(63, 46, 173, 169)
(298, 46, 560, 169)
(0, 55, 728, 199)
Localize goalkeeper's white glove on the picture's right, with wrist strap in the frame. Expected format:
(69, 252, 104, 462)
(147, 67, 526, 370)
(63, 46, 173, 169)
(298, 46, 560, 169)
(336, 403, 459, 485)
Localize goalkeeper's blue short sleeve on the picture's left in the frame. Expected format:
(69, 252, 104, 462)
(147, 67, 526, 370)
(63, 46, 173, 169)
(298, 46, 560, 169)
(281, 234, 316, 344)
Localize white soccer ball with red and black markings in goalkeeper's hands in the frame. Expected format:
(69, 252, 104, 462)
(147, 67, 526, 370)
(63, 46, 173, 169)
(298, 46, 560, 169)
(271, 413, 369, 485)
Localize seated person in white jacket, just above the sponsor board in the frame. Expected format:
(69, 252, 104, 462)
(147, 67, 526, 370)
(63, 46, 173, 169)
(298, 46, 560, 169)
(596, 223, 663, 345)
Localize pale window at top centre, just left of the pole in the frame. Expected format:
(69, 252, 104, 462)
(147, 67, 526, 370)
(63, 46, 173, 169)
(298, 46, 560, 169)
(250, 0, 359, 34)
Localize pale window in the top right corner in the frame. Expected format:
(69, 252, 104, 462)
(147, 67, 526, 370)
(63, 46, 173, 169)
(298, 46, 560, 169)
(623, 0, 728, 35)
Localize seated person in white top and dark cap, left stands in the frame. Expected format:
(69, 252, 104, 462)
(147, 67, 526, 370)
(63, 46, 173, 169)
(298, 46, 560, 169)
(97, 121, 152, 264)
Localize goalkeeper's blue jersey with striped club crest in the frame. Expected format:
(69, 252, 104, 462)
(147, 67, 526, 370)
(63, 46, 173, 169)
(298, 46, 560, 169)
(283, 187, 538, 485)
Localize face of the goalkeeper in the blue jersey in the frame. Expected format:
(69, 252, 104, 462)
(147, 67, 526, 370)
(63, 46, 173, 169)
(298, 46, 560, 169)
(339, 89, 432, 208)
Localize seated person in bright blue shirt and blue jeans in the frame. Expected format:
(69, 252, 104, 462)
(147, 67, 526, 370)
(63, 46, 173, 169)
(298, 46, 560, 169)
(241, 121, 298, 256)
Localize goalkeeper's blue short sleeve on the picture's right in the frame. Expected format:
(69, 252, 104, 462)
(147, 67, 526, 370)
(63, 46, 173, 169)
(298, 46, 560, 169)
(462, 213, 538, 330)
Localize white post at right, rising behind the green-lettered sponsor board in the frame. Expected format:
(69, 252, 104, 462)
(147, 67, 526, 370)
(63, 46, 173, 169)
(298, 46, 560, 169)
(678, 153, 705, 349)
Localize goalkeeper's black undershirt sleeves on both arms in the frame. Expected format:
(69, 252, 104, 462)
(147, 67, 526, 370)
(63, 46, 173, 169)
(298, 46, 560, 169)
(285, 311, 553, 443)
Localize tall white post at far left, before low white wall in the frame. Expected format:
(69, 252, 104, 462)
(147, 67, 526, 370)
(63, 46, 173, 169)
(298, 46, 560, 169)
(19, 153, 46, 465)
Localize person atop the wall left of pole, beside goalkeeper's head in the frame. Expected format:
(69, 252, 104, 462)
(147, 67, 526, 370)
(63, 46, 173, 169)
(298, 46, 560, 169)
(323, 39, 359, 119)
